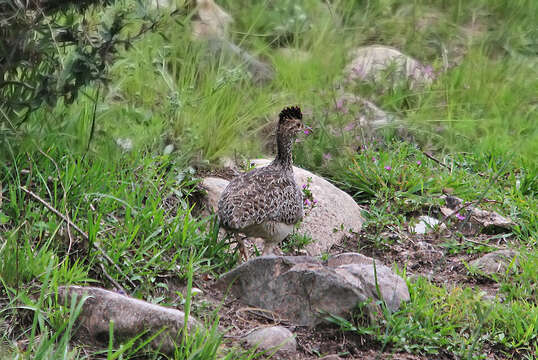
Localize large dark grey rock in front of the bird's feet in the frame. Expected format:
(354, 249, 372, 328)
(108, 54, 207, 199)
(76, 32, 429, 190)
(218, 256, 367, 326)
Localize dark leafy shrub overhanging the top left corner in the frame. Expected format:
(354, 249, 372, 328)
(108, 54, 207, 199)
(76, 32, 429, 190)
(0, 0, 165, 131)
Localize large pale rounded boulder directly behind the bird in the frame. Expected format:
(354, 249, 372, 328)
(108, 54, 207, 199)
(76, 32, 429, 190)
(202, 159, 364, 256)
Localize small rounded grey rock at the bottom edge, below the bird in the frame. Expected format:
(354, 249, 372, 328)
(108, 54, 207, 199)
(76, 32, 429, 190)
(245, 326, 297, 357)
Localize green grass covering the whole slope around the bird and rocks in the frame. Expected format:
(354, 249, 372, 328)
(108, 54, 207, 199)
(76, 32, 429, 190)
(0, 0, 538, 359)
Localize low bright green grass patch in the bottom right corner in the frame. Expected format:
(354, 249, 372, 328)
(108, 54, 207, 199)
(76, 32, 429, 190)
(329, 278, 538, 359)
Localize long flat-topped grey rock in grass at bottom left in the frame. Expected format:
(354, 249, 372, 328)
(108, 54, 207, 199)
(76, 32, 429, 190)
(58, 286, 202, 354)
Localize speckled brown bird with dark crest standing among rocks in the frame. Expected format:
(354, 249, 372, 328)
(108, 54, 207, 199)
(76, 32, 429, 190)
(218, 106, 307, 259)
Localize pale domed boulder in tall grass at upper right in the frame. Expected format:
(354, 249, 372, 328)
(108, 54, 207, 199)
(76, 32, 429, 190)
(344, 45, 435, 87)
